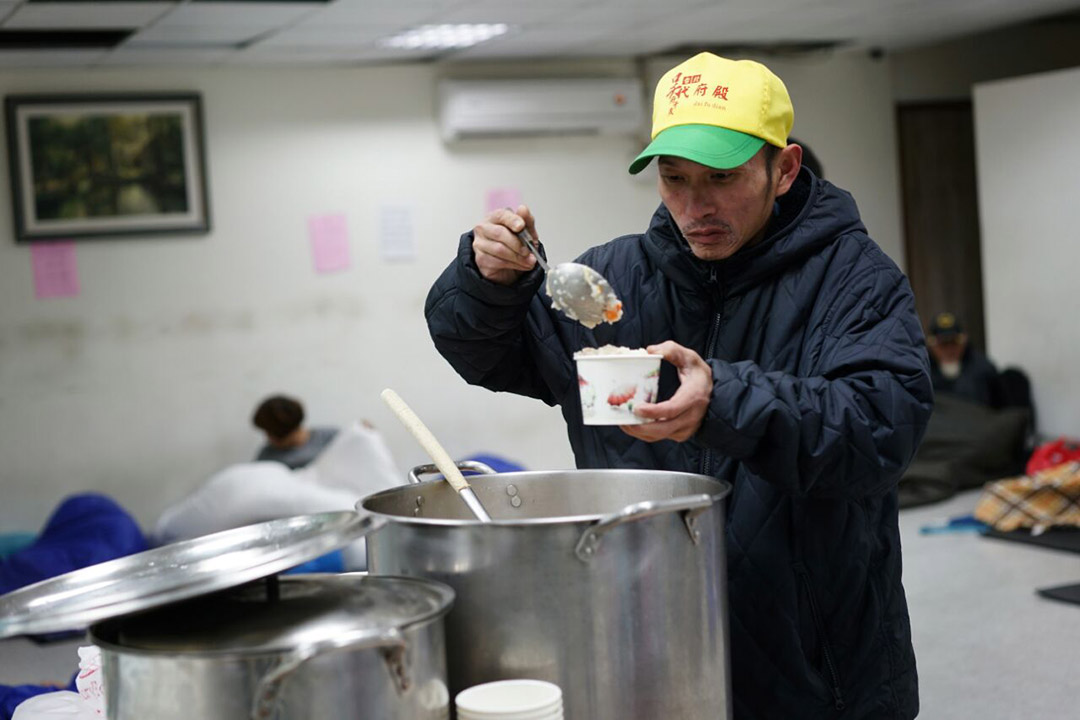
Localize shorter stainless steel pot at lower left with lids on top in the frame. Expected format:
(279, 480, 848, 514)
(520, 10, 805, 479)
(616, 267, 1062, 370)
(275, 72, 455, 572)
(0, 512, 454, 720)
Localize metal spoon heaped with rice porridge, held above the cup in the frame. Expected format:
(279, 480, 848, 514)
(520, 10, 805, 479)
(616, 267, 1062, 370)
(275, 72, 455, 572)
(517, 230, 622, 327)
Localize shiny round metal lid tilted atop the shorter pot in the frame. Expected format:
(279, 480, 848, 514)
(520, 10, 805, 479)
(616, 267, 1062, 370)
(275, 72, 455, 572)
(0, 511, 386, 638)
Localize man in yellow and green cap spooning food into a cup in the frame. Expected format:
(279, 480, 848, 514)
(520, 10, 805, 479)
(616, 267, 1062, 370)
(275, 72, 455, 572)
(426, 53, 932, 720)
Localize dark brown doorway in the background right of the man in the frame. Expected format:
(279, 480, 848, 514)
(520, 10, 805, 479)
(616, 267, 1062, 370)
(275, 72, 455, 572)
(896, 100, 986, 351)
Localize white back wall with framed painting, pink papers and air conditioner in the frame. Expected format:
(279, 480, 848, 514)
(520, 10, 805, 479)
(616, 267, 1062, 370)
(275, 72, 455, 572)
(0, 50, 901, 532)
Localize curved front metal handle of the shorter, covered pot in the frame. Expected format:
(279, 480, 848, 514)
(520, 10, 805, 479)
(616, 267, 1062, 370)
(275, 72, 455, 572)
(251, 628, 411, 720)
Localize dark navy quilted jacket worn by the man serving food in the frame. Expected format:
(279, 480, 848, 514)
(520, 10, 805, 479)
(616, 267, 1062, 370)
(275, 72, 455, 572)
(426, 169, 932, 720)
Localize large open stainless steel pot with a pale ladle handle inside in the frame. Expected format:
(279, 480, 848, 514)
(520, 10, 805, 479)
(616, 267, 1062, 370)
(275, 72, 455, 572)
(361, 467, 731, 720)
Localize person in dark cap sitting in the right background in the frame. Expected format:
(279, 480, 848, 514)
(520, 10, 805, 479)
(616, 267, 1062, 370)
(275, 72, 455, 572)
(927, 312, 1000, 406)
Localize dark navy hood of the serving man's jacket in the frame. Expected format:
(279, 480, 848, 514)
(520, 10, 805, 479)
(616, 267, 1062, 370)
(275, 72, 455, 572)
(645, 168, 865, 293)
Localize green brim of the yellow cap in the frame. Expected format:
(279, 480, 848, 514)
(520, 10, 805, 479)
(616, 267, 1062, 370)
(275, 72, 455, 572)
(630, 125, 765, 175)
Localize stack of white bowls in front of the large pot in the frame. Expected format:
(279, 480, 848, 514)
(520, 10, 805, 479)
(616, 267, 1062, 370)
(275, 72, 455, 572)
(455, 680, 563, 720)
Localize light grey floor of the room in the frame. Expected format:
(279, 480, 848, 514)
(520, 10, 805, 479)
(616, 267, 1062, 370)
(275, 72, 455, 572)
(6, 492, 1080, 720)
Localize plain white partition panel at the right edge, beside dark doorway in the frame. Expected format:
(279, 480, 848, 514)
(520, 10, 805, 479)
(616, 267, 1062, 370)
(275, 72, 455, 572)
(974, 69, 1080, 436)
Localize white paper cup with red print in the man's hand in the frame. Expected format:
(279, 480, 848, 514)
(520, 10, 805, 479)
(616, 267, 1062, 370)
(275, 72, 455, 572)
(575, 354, 662, 425)
